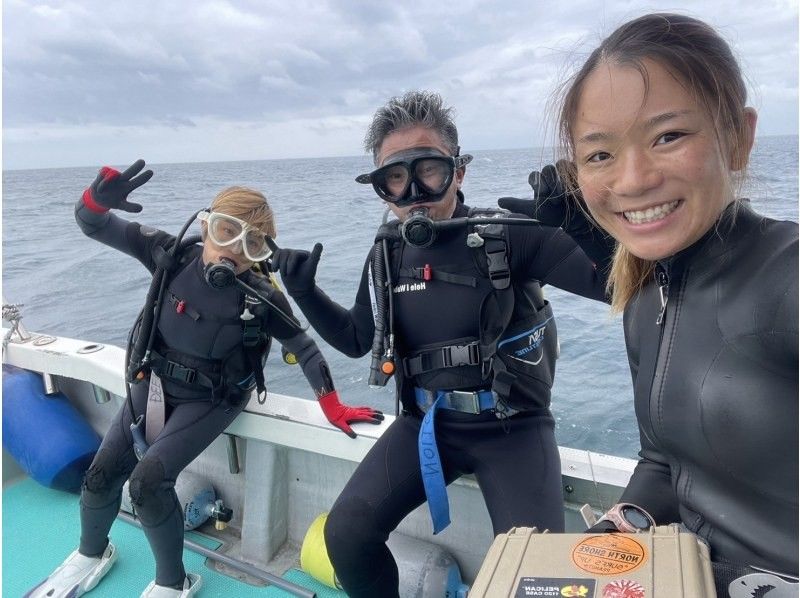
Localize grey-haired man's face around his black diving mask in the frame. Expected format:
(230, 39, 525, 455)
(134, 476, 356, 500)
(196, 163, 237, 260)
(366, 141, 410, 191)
(377, 125, 465, 221)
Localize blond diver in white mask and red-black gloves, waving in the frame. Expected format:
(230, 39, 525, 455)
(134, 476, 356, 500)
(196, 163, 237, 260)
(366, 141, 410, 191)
(28, 160, 383, 598)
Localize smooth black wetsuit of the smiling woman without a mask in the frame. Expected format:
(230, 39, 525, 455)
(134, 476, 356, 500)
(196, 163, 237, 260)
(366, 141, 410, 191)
(622, 203, 798, 596)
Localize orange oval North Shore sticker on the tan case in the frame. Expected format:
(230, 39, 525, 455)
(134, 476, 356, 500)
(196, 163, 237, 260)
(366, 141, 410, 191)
(572, 534, 647, 575)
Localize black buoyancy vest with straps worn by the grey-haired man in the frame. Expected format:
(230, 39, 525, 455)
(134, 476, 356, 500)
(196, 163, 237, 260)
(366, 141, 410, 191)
(378, 208, 558, 411)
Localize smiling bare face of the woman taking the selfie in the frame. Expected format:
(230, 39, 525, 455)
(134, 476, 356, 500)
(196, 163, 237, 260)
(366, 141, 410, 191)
(572, 59, 755, 260)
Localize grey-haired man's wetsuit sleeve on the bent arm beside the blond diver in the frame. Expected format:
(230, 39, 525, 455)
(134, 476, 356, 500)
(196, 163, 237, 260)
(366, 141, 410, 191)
(294, 252, 375, 357)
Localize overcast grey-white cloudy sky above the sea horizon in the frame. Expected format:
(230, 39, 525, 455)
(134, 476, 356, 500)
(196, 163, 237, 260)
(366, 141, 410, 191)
(2, 0, 798, 169)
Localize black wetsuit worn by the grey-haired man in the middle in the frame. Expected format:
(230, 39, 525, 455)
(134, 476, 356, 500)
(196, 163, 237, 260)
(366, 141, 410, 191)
(284, 203, 604, 597)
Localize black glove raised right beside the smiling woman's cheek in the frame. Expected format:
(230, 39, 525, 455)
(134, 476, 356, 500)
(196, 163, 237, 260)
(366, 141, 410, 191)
(497, 160, 595, 237)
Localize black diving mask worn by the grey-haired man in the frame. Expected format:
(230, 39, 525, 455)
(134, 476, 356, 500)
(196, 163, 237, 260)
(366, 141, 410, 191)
(356, 147, 472, 207)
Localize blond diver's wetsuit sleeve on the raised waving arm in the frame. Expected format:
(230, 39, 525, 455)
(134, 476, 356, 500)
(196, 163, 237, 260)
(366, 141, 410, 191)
(75, 199, 174, 272)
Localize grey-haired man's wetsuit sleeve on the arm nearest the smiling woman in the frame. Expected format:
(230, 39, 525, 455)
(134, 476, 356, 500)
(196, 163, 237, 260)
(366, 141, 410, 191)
(508, 220, 610, 301)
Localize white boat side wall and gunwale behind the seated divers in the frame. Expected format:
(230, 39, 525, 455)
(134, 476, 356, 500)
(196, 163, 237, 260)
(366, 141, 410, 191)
(3, 308, 635, 595)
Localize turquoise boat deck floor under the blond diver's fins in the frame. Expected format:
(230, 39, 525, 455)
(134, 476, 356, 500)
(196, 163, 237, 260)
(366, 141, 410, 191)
(2, 478, 346, 598)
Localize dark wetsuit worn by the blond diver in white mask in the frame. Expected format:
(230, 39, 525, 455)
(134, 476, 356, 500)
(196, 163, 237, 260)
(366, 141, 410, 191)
(75, 200, 333, 586)
